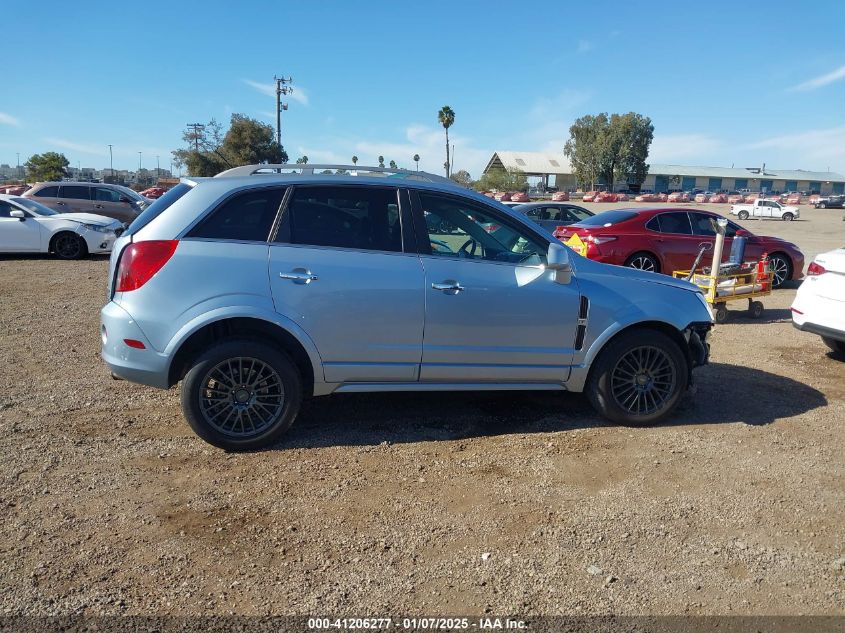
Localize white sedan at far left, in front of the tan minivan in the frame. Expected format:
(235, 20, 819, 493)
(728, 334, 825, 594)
(0, 195, 124, 259)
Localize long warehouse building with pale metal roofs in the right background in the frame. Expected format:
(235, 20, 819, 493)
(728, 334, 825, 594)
(484, 151, 845, 194)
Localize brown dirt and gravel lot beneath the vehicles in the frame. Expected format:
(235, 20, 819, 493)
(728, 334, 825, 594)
(0, 205, 845, 615)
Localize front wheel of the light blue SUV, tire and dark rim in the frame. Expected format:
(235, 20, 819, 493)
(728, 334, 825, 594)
(586, 329, 689, 426)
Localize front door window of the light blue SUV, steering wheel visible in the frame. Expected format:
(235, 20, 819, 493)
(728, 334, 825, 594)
(419, 192, 548, 266)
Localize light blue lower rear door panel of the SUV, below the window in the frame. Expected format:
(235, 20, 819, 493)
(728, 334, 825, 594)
(270, 244, 425, 382)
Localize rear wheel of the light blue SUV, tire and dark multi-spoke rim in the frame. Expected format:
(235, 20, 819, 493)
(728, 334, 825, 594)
(182, 339, 302, 451)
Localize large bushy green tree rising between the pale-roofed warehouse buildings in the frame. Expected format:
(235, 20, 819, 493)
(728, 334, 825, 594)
(563, 112, 654, 191)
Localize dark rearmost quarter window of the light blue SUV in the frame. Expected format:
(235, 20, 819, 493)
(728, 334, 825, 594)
(187, 189, 285, 242)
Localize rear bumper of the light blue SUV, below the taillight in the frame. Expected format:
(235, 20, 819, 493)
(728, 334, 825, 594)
(100, 301, 170, 389)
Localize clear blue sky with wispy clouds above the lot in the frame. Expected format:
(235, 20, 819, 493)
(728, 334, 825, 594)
(0, 0, 845, 177)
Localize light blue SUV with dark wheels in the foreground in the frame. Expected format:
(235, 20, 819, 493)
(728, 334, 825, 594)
(101, 165, 711, 450)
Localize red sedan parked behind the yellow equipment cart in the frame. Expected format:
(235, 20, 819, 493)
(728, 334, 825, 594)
(554, 208, 804, 287)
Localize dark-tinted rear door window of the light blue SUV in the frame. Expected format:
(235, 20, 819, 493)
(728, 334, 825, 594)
(276, 186, 402, 253)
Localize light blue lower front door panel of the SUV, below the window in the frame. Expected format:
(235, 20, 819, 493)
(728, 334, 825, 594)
(420, 256, 580, 382)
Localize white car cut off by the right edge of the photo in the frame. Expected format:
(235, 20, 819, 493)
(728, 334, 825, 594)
(792, 248, 845, 355)
